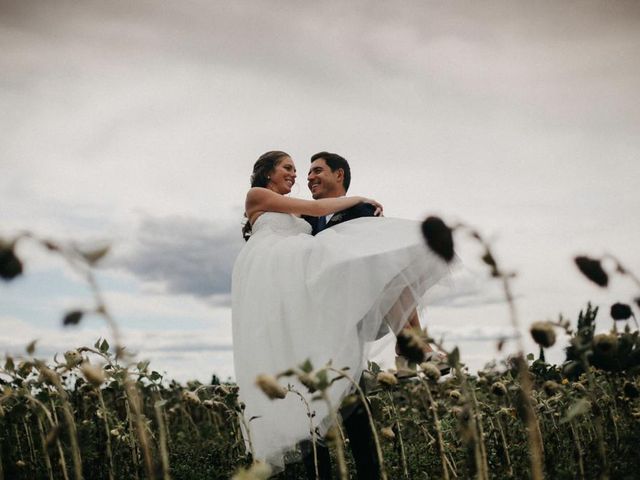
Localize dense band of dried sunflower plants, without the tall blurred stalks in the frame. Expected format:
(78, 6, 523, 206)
(0, 302, 640, 479)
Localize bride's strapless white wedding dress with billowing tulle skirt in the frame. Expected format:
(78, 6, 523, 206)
(232, 212, 449, 468)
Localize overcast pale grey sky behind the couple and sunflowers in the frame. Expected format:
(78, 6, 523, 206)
(0, 0, 640, 380)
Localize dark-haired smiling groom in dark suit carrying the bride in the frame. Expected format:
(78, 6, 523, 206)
(301, 152, 380, 480)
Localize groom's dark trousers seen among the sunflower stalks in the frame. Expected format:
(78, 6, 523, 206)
(300, 399, 380, 480)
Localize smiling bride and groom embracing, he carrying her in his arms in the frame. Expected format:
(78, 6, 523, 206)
(232, 151, 449, 479)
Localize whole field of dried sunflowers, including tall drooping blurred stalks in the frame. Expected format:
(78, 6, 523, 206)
(0, 218, 640, 480)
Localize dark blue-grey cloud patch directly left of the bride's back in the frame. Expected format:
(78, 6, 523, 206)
(111, 217, 244, 302)
